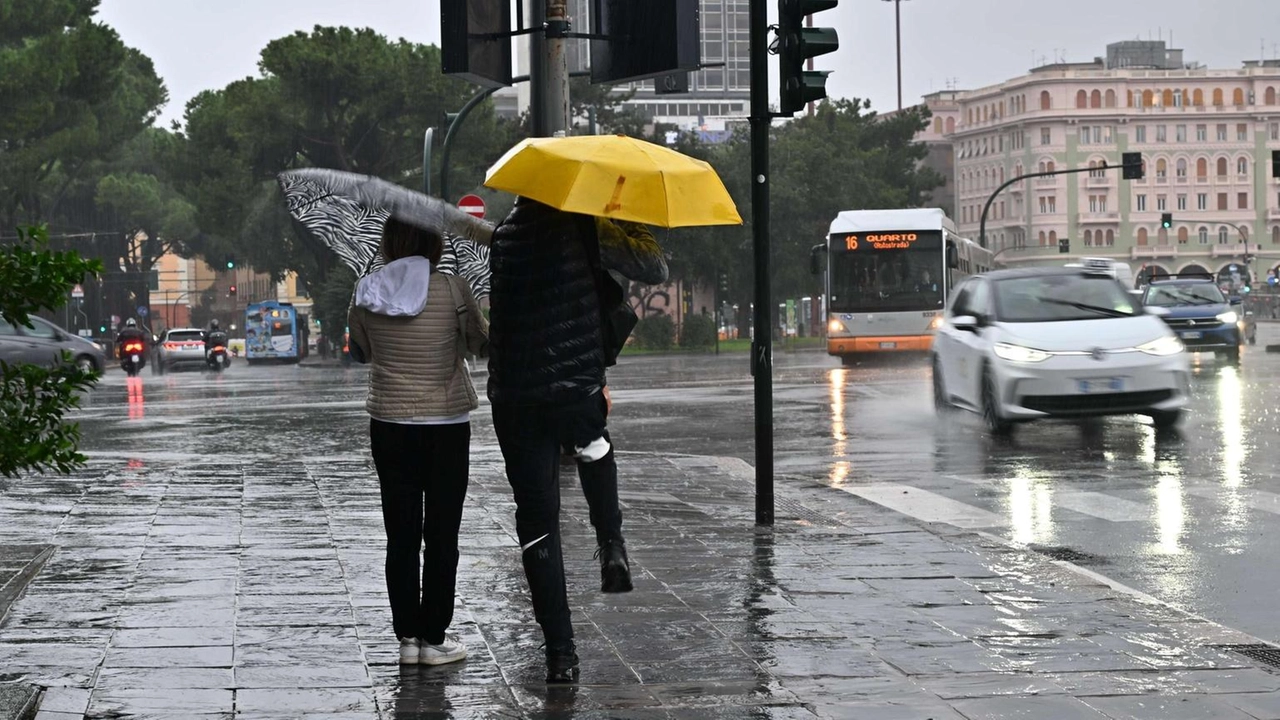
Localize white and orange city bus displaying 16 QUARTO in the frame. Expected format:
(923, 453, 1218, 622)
(813, 208, 995, 363)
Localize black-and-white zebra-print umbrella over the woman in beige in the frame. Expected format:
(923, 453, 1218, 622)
(276, 168, 493, 299)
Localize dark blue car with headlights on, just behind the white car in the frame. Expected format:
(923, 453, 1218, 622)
(1142, 277, 1239, 363)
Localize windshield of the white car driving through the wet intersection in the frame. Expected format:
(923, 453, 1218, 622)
(995, 273, 1140, 323)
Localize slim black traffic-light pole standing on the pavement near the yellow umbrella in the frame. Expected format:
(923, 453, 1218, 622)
(749, 0, 773, 525)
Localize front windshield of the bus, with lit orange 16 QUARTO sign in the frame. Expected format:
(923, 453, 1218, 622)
(828, 231, 946, 313)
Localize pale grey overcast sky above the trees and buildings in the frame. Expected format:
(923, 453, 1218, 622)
(100, 0, 1280, 126)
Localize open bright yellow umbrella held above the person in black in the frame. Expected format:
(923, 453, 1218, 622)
(484, 135, 742, 228)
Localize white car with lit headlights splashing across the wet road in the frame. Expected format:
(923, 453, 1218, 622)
(932, 268, 1190, 433)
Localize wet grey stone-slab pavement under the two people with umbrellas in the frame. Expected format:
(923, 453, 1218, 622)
(0, 368, 1280, 720)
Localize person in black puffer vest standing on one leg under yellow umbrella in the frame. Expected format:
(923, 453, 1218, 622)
(489, 197, 666, 682)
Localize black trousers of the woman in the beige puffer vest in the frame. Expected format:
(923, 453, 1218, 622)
(369, 420, 471, 644)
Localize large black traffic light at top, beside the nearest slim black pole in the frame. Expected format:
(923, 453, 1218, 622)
(778, 0, 840, 115)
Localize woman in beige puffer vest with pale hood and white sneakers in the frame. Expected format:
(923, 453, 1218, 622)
(347, 219, 489, 665)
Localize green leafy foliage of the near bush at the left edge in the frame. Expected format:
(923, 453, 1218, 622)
(0, 228, 102, 478)
